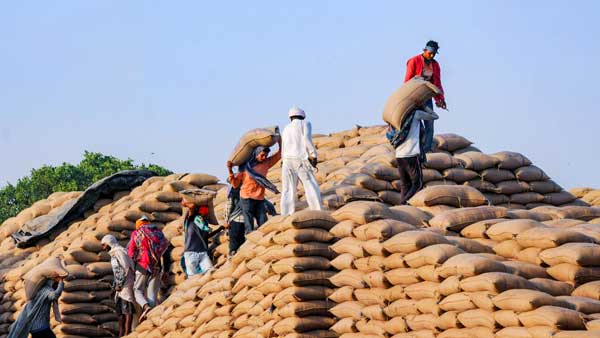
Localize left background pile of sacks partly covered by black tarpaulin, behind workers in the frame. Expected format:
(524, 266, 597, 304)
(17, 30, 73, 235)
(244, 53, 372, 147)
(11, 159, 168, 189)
(0, 174, 222, 337)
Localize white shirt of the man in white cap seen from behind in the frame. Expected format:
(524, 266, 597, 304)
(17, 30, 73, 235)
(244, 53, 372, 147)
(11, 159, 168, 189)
(281, 119, 317, 160)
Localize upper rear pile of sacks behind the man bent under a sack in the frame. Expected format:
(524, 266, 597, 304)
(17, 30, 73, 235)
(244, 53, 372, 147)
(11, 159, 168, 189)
(268, 126, 583, 209)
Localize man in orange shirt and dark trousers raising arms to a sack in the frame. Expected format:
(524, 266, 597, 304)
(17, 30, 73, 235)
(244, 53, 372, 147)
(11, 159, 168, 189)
(227, 138, 281, 232)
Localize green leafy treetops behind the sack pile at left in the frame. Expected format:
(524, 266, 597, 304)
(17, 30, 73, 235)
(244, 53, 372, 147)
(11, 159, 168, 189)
(0, 151, 172, 224)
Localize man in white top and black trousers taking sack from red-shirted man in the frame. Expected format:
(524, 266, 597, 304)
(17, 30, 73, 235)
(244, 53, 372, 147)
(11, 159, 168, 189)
(394, 107, 439, 204)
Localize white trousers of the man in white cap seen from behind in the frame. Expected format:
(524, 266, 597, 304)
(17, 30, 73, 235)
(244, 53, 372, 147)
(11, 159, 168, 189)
(281, 159, 323, 215)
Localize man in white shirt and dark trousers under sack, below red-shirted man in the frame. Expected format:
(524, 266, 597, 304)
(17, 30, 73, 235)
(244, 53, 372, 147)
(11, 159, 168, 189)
(386, 107, 439, 204)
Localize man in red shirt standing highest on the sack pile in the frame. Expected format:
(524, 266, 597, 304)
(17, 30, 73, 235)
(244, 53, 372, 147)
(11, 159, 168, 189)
(404, 40, 446, 153)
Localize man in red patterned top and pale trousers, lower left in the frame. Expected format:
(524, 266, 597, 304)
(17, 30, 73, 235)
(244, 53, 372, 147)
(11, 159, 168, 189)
(127, 216, 169, 322)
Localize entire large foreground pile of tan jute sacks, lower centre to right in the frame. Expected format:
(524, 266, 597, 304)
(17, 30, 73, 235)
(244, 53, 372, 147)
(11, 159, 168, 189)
(123, 201, 600, 338)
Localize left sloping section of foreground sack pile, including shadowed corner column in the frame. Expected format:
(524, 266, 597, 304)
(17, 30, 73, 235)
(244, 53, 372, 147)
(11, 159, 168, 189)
(123, 211, 336, 338)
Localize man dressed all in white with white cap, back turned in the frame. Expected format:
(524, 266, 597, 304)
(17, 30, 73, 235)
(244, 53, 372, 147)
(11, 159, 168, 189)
(281, 107, 322, 215)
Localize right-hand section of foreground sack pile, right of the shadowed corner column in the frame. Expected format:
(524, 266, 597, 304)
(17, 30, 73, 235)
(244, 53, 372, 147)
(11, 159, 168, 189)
(330, 202, 600, 338)
